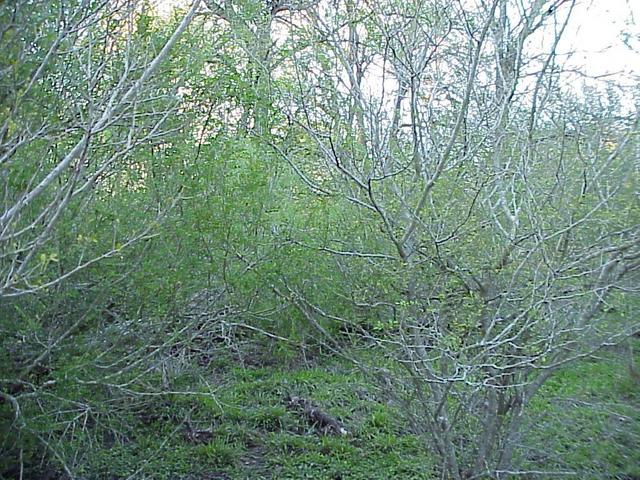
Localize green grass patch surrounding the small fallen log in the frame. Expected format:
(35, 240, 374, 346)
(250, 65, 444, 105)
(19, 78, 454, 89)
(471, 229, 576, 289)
(60, 348, 433, 480)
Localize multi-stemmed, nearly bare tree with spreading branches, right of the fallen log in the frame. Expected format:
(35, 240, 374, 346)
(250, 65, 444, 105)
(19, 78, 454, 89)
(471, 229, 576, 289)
(272, 0, 640, 480)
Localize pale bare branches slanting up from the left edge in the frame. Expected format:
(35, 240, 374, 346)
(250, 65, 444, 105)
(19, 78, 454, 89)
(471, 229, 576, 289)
(0, 0, 200, 298)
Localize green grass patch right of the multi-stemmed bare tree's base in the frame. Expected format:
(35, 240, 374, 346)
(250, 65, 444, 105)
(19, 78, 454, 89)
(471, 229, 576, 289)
(525, 348, 640, 480)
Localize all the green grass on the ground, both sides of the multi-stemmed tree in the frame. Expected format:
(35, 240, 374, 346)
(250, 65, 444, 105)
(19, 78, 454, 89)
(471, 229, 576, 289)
(6, 340, 640, 480)
